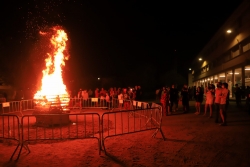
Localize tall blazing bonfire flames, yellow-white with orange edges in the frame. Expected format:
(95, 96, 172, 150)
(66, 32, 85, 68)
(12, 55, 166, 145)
(34, 27, 69, 104)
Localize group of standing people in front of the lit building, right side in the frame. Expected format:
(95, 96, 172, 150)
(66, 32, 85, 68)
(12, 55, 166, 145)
(159, 82, 250, 126)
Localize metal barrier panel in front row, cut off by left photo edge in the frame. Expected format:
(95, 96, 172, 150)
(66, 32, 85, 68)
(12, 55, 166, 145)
(0, 115, 21, 160)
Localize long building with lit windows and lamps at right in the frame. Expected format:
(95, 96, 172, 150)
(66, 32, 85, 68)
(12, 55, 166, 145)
(192, 0, 250, 97)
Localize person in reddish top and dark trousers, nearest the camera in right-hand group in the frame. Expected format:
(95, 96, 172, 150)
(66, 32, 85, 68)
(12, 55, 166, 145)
(220, 83, 228, 126)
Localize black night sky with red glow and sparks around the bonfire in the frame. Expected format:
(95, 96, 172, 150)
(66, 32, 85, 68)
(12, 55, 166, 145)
(0, 0, 242, 90)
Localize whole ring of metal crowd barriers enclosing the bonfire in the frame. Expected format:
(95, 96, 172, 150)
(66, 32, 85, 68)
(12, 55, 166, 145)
(0, 99, 165, 160)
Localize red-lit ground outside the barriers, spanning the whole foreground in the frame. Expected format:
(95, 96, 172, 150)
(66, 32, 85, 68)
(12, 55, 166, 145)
(0, 101, 250, 167)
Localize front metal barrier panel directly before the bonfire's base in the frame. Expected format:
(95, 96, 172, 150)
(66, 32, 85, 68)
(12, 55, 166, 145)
(9, 113, 101, 160)
